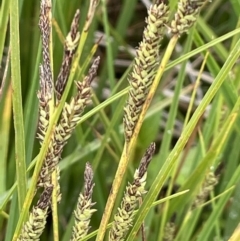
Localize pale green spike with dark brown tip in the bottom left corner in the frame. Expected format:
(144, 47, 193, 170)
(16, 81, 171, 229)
(17, 187, 53, 241)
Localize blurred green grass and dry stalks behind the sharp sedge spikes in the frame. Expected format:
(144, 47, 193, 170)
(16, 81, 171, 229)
(0, 0, 240, 241)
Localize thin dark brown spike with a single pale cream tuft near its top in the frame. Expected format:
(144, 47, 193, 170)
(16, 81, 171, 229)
(55, 10, 80, 100)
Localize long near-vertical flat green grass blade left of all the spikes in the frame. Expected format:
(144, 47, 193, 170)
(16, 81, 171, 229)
(10, 0, 27, 210)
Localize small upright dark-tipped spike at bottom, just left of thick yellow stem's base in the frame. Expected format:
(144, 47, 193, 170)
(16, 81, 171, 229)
(71, 163, 96, 241)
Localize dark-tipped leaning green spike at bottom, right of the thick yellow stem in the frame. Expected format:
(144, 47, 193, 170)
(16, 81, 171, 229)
(109, 143, 155, 241)
